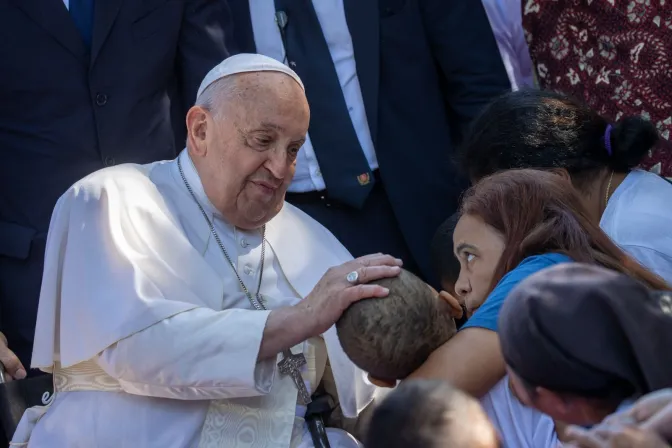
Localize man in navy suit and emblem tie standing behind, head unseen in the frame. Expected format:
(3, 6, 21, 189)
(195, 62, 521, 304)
(229, 0, 511, 286)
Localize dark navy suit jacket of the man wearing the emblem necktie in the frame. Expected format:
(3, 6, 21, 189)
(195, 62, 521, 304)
(229, 0, 511, 284)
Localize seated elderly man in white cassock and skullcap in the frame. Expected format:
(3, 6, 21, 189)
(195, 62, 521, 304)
(14, 54, 401, 448)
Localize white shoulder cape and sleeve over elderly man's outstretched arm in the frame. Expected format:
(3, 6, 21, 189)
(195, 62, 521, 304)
(32, 165, 275, 399)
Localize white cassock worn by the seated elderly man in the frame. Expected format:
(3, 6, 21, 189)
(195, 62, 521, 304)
(14, 151, 375, 448)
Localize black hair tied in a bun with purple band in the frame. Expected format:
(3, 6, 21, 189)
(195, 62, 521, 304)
(458, 90, 659, 189)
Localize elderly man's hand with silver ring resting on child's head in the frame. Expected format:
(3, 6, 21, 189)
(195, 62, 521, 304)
(296, 254, 402, 335)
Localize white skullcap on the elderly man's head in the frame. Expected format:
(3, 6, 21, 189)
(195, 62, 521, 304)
(196, 53, 305, 99)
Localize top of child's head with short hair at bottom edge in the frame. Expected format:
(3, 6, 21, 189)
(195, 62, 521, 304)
(365, 380, 499, 448)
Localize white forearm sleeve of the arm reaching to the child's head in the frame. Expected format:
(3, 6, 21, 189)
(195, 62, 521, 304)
(96, 308, 276, 400)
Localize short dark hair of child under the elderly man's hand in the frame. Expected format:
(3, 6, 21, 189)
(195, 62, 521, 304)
(336, 270, 456, 381)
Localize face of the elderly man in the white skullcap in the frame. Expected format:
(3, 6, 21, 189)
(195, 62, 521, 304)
(187, 72, 310, 229)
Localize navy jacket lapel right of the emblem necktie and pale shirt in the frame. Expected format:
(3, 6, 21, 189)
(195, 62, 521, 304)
(344, 0, 380, 145)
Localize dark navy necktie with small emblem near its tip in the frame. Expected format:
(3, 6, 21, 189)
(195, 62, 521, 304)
(275, 0, 374, 208)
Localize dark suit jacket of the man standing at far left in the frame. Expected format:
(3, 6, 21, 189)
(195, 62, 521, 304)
(0, 0, 229, 367)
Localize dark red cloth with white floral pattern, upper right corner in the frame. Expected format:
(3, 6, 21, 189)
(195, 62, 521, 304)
(522, 0, 672, 177)
